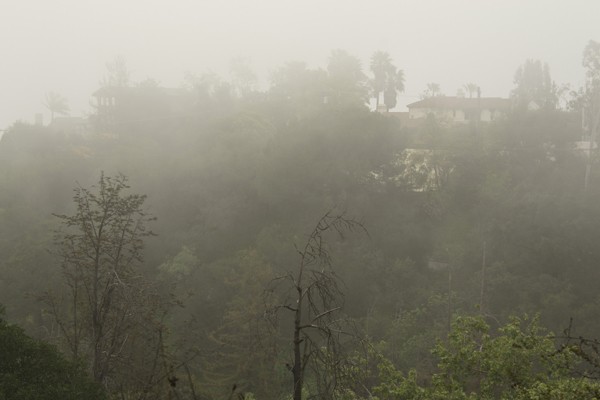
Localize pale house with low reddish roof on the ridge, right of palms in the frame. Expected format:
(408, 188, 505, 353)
(407, 96, 511, 123)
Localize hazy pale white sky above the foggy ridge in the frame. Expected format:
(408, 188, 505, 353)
(0, 0, 600, 129)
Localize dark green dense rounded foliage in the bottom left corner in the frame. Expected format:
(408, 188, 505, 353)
(0, 307, 106, 400)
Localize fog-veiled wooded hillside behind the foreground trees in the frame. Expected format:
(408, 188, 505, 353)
(5, 50, 600, 398)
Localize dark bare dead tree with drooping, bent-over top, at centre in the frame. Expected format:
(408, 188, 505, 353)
(269, 212, 366, 400)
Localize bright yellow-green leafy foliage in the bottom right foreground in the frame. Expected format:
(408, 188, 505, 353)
(374, 317, 600, 400)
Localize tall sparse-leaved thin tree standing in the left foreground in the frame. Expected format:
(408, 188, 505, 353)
(42, 174, 166, 391)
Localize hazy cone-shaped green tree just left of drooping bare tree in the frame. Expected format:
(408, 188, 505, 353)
(198, 249, 280, 398)
